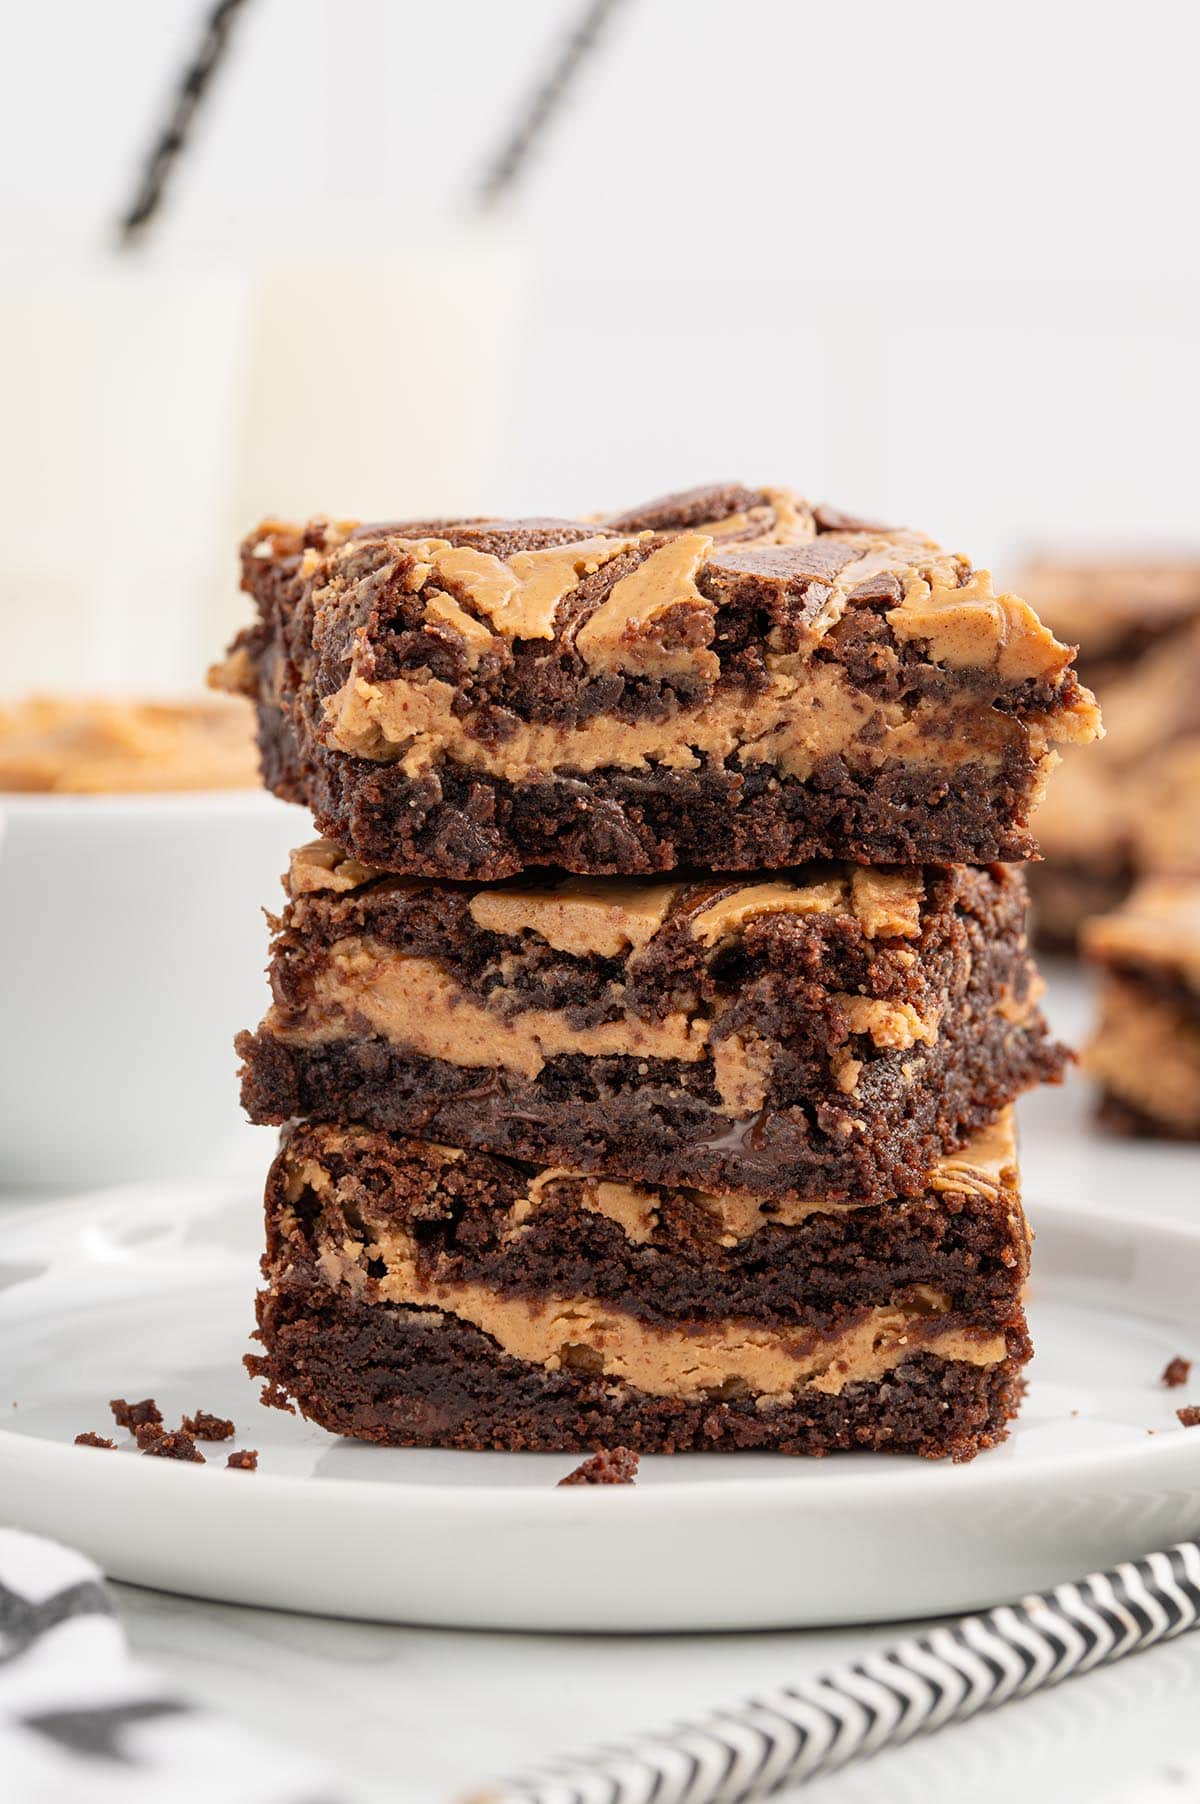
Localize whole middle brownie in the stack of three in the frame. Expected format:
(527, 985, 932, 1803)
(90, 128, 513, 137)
(238, 842, 1063, 1200)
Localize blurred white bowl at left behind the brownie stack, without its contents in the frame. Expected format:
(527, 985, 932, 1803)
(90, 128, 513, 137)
(0, 790, 312, 1191)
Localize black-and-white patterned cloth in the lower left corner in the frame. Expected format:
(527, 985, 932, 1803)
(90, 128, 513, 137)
(0, 1528, 345, 1804)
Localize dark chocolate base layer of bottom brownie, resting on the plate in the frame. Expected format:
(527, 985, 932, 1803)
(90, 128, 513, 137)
(247, 1284, 1030, 1459)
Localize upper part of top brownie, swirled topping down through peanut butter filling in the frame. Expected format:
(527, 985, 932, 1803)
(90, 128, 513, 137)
(226, 487, 1099, 783)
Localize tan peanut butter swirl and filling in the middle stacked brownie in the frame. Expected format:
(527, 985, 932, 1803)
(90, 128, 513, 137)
(263, 855, 940, 1117)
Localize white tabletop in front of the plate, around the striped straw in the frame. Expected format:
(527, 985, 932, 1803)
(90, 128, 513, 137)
(18, 980, 1200, 1804)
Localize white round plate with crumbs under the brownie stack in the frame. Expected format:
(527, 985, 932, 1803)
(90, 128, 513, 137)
(0, 1060, 1200, 1631)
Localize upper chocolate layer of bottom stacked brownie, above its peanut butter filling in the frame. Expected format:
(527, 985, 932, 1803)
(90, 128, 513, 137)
(267, 1111, 1029, 1335)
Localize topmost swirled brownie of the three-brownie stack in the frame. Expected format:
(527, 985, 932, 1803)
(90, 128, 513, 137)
(215, 485, 1099, 880)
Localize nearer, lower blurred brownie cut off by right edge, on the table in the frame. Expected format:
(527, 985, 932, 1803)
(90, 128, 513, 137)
(1083, 877, 1200, 1140)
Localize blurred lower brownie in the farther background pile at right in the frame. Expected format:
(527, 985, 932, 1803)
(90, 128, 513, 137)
(1029, 621, 1200, 951)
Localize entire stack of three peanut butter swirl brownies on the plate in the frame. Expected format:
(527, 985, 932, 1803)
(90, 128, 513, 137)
(218, 485, 1099, 1458)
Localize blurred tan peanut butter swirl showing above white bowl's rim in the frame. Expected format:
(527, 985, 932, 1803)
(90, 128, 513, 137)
(0, 696, 258, 796)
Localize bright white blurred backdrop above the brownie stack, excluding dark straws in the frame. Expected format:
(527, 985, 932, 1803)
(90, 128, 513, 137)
(0, 0, 1200, 686)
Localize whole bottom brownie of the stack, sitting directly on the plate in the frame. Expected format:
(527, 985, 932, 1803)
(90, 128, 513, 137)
(249, 1117, 1029, 1459)
